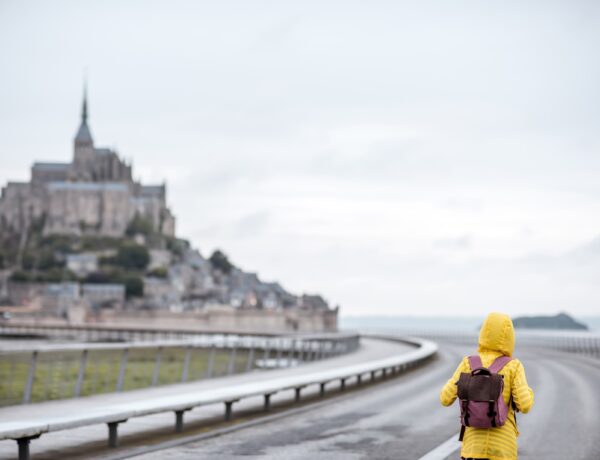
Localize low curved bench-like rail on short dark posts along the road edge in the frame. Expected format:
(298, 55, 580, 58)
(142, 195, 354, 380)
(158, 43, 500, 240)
(0, 337, 437, 460)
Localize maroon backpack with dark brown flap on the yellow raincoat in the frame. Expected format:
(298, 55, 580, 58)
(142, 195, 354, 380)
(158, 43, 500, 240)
(457, 355, 512, 441)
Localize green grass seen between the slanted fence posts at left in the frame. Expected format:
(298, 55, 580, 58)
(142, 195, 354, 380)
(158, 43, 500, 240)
(0, 347, 262, 406)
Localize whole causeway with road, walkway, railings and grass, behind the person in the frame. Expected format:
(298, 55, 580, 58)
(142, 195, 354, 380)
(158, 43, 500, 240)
(0, 323, 600, 460)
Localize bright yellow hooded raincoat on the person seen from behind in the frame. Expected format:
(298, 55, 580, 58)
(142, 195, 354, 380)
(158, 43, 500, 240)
(440, 313, 533, 460)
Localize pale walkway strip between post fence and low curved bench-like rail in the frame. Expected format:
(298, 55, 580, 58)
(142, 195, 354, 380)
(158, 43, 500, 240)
(0, 339, 413, 460)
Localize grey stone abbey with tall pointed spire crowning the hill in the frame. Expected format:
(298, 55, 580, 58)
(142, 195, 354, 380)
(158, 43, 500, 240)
(0, 90, 175, 237)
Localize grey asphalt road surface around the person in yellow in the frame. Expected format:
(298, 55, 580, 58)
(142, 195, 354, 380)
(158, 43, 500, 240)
(135, 344, 600, 460)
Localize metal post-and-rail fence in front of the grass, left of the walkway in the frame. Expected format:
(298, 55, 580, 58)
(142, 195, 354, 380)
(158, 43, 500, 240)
(0, 334, 359, 406)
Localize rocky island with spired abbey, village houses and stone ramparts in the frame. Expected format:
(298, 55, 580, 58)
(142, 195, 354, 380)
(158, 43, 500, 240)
(0, 87, 338, 332)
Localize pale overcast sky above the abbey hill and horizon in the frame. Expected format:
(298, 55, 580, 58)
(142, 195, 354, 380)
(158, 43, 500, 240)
(0, 0, 600, 315)
